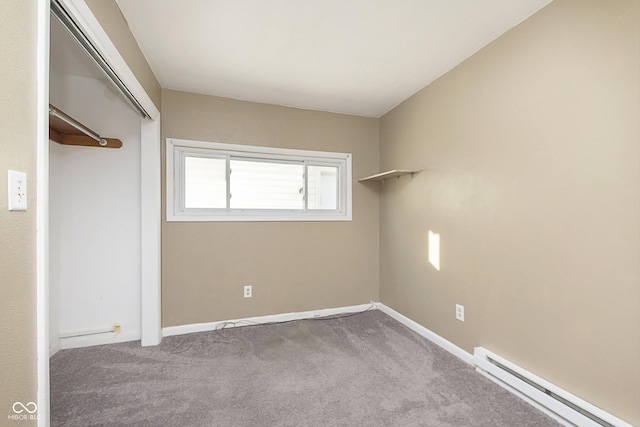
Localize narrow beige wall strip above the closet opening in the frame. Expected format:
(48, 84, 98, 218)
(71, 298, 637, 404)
(85, 0, 161, 110)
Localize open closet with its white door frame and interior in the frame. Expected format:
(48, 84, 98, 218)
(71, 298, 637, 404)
(36, 0, 162, 425)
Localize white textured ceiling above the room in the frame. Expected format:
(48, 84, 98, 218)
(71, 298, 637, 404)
(116, 0, 550, 117)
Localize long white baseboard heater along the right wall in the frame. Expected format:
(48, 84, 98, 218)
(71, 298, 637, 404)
(473, 347, 633, 427)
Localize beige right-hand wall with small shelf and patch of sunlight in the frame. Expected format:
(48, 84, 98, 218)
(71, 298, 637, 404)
(380, 0, 640, 425)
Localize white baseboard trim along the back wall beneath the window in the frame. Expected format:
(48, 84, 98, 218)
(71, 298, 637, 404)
(162, 301, 378, 337)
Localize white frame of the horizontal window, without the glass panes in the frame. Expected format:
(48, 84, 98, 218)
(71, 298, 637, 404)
(166, 138, 352, 221)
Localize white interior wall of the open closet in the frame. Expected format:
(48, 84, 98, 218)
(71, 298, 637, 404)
(49, 22, 140, 353)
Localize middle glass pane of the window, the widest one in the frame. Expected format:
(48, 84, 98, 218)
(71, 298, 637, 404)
(230, 158, 304, 209)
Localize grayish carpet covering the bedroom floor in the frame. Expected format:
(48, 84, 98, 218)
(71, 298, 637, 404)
(51, 310, 559, 427)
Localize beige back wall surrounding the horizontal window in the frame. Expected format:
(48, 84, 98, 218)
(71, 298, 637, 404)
(162, 90, 379, 326)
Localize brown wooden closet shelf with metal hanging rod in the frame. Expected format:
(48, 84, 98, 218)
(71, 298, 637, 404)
(49, 104, 122, 148)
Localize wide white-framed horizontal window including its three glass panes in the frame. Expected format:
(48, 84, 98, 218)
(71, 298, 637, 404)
(167, 138, 351, 221)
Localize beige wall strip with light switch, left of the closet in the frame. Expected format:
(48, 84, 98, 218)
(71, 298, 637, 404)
(0, 0, 37, 425)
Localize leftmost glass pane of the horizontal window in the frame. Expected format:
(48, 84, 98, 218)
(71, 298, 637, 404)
(184, 156, 227, 209)
